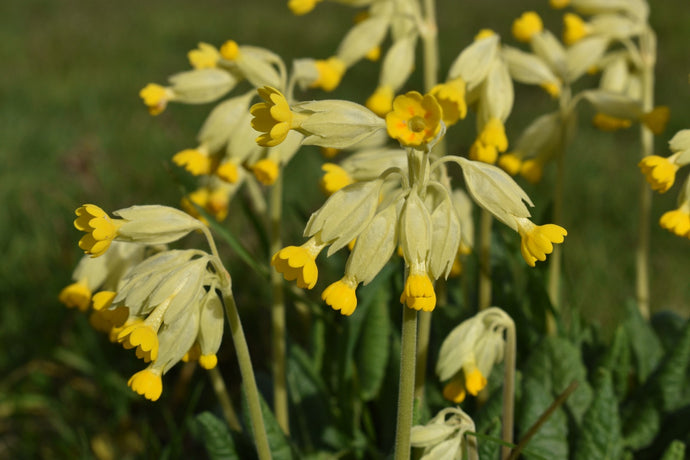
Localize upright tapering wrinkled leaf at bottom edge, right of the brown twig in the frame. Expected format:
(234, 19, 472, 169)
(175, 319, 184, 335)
(575, 368, 623, 460)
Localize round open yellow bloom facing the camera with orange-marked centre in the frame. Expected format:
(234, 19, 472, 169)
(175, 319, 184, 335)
(386, 91, 441, 147)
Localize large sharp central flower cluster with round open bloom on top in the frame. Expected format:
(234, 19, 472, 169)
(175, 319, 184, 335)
(260, 88, 566, 315)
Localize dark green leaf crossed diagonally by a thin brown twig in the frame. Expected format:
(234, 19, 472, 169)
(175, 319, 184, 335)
(517, 376, 568, 458)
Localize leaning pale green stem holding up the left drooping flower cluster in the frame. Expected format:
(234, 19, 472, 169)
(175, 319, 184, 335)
(223, 286, 271, 460)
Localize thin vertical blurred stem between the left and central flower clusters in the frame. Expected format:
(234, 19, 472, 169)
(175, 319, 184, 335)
(269, 171, 290, 434)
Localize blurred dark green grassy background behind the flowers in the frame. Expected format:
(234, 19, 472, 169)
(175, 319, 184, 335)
(0, 0, 690, 458)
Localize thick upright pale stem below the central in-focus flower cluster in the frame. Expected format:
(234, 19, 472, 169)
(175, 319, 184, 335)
(395, 305, 417, 460)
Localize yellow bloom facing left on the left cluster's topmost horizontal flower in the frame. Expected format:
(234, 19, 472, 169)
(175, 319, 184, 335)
(74, 204, 123, 257)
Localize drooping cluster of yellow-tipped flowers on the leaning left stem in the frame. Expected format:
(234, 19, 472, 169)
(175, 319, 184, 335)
(60, 204, 224, 401)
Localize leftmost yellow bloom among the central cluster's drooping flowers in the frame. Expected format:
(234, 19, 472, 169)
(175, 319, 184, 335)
(271, 238, 325, 289)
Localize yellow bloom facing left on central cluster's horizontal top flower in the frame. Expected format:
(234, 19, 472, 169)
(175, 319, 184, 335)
(249, 86, 293, 147)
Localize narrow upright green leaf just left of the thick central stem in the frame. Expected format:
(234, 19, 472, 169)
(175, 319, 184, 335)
(356, 289, 391, 401)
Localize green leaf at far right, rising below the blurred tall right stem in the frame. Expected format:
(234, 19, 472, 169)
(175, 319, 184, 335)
(624, 304, 664, 383)
